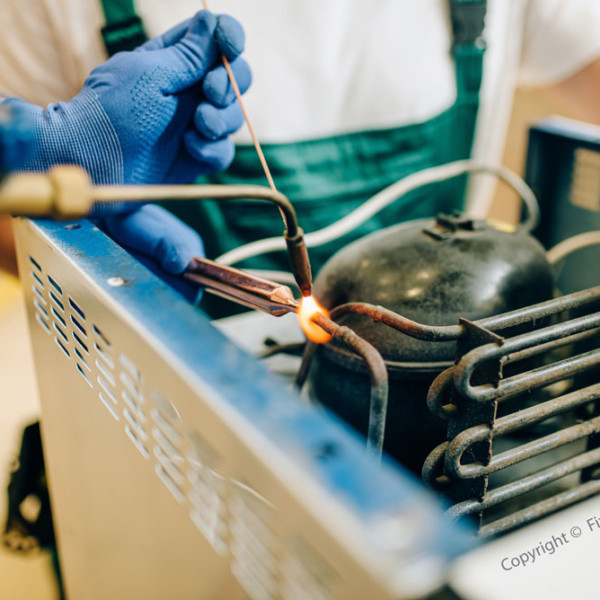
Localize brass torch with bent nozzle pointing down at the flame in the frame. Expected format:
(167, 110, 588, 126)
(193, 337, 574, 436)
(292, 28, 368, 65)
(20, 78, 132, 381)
(0, 165, 312, 296)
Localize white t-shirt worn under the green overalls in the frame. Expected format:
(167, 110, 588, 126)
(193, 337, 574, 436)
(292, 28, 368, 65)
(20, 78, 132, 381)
(0, 0, 600, 213)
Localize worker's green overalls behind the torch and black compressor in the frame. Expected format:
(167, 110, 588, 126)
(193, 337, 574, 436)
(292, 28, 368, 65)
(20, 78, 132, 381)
(103, 0, 486, 314)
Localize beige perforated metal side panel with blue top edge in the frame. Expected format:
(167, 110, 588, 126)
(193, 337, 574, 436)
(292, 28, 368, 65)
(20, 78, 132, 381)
(16, 220, 472, 600)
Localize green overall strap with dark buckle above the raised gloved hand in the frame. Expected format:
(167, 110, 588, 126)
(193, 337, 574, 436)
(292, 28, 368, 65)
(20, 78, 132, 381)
(100, 0, 148, 56)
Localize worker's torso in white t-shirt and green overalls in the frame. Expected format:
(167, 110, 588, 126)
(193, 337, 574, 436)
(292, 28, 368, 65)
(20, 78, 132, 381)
(0, 0, 600, 312)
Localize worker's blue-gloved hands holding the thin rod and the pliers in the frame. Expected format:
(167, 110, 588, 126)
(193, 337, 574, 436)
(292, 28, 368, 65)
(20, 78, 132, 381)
(0, 11, 251, 298)
